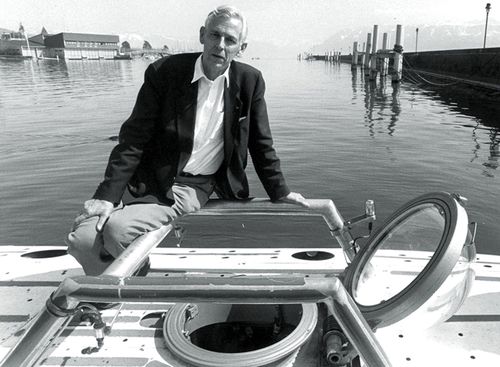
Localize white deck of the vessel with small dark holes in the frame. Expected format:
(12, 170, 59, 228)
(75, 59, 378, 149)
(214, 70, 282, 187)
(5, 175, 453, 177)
(0, 246, 500, 367)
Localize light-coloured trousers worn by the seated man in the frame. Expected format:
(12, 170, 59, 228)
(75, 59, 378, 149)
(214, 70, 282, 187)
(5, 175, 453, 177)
(66, 176, 215, 275)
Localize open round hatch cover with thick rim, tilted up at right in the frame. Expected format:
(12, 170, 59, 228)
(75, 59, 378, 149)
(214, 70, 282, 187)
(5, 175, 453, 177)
(344, 192, 469, 327)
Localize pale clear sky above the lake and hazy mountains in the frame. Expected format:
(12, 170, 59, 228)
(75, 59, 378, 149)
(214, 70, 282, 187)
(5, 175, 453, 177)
(0, 0, 500, 50)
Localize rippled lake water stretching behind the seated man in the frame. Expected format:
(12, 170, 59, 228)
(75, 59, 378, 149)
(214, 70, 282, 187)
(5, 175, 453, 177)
(0, 60, 500, 254)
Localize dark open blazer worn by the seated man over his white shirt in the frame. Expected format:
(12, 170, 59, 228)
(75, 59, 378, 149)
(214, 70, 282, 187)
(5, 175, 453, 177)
(94, 53, 290, 204)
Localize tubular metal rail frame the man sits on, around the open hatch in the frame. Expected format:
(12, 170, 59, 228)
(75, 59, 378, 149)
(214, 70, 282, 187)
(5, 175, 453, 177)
(1, 199, 390, 367)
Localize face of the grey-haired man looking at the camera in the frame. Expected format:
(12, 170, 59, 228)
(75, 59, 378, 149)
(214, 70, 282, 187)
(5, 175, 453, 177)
(200, 17, 247, 80)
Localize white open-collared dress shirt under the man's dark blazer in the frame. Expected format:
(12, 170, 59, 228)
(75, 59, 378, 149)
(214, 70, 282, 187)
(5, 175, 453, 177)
(184, 55, 229, 175)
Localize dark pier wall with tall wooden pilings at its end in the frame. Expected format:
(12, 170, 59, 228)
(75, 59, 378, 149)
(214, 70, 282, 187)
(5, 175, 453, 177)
(300, 25, 500, 91)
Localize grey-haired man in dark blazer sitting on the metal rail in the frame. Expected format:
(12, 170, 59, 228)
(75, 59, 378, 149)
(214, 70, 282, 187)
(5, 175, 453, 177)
(67, 6, 308, 275)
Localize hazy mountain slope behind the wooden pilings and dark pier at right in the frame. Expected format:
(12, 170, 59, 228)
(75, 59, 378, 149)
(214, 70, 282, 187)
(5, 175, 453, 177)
(310, 24, 500, 54)
